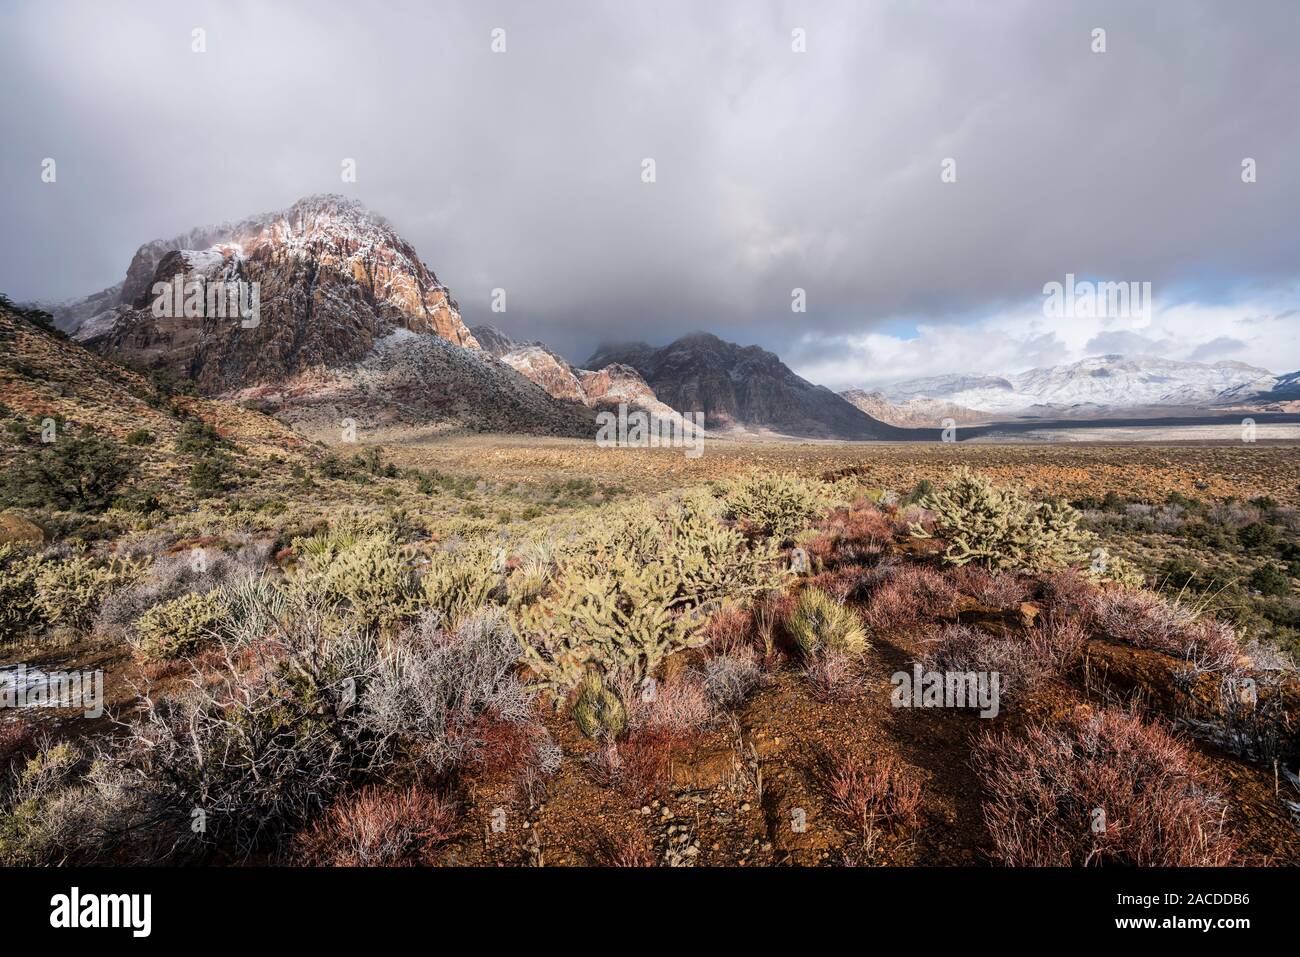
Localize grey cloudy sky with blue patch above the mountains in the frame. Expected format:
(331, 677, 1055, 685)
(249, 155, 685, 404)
(0, 0, 1300, 387)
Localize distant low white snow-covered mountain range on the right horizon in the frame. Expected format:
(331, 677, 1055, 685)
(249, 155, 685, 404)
(884, 355, 1278, 415)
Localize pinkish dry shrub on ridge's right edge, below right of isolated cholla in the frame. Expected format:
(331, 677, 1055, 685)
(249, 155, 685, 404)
(1092, 588, 1242, 671)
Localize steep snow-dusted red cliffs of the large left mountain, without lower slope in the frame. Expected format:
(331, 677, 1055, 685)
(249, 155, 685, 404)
(55, 195, 477, 394)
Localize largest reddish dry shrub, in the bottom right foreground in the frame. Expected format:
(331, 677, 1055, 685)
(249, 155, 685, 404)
(974, 709, 1236, 867)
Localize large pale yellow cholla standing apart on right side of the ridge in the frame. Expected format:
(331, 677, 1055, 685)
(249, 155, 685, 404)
(911, 468, 1092, 571)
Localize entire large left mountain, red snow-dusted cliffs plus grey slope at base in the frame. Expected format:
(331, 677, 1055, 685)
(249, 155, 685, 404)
(34, 195, 595, 436)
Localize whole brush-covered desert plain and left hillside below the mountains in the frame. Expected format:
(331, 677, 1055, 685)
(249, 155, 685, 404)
(0, 343, 1300, 867)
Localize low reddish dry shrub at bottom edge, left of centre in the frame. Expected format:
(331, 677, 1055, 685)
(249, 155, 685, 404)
(299, 785, 459, 867)
